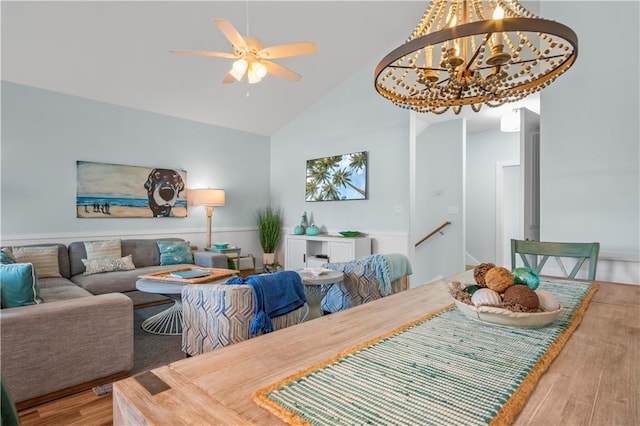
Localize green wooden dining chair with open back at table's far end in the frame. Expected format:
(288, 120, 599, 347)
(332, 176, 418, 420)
(511, 240, 600, 280)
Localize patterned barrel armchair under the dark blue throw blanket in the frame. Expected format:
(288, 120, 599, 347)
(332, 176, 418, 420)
(182, 284, 308, 356)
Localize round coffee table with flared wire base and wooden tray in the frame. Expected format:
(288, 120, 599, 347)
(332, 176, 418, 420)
(136, 267, 238, 336)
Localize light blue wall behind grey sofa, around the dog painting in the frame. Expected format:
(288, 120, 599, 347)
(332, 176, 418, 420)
(1, 82, 269, 239)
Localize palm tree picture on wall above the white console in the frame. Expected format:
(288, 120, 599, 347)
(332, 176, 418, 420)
(305, 151, 367, 201)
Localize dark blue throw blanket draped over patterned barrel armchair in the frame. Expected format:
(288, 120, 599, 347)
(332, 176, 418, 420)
(227, 271, 307, 336)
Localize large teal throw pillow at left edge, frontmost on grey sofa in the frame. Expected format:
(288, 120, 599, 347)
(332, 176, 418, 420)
(0, 263, 44, 308)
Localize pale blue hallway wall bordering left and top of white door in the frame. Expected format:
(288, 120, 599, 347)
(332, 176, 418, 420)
(466, 130, 520, 262)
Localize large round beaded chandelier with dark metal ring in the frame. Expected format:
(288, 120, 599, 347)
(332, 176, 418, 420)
(374, 0, 578, 114)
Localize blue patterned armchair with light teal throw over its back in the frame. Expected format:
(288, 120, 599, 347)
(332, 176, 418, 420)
(320, 254, 411, 312)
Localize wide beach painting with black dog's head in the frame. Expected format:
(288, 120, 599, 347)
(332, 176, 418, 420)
(76, 161, 187, 218)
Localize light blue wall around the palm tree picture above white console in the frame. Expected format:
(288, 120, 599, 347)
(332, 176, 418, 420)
(271, 60, 409, 233)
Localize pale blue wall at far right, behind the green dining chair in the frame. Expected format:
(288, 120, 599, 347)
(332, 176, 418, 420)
(540, 1, 640, 255)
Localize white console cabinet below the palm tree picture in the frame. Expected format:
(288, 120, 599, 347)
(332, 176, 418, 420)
(284, 234, 371, 270)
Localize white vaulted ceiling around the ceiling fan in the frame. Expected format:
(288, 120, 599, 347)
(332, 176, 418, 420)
(1, 1, 535, 135)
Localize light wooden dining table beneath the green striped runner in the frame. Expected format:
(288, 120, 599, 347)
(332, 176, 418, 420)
(113, 271, 640, 425)
